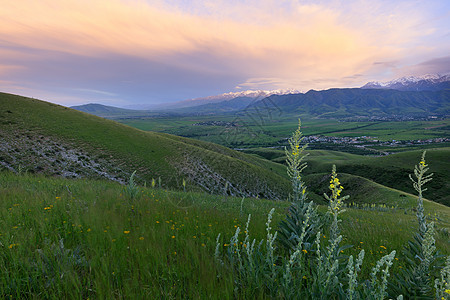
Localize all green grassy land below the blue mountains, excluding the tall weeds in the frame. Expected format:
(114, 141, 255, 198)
(0, 93, 450, 298)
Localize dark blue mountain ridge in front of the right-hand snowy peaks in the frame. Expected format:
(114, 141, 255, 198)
(249, 88, 450, 118)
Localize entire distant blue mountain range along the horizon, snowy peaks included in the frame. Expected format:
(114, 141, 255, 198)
(72, 82, 450, 119)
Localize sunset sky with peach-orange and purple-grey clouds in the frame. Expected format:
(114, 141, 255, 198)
(0, 0, 450, 107)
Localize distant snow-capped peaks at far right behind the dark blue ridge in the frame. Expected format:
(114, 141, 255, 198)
(361, 74, 450, 91)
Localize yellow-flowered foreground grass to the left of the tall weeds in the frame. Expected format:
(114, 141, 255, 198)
(0, 173, 282, 299)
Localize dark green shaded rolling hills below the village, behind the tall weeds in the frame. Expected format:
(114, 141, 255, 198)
(245, 148, 450, 206)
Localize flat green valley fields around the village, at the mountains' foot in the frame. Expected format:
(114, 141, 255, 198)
(115, 114, 450, 153)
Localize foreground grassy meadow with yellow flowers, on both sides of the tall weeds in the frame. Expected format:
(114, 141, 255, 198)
(0, 172, 450, 299)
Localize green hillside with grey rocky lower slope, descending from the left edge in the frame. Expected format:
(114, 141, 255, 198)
(0, 93, 289, 199)
